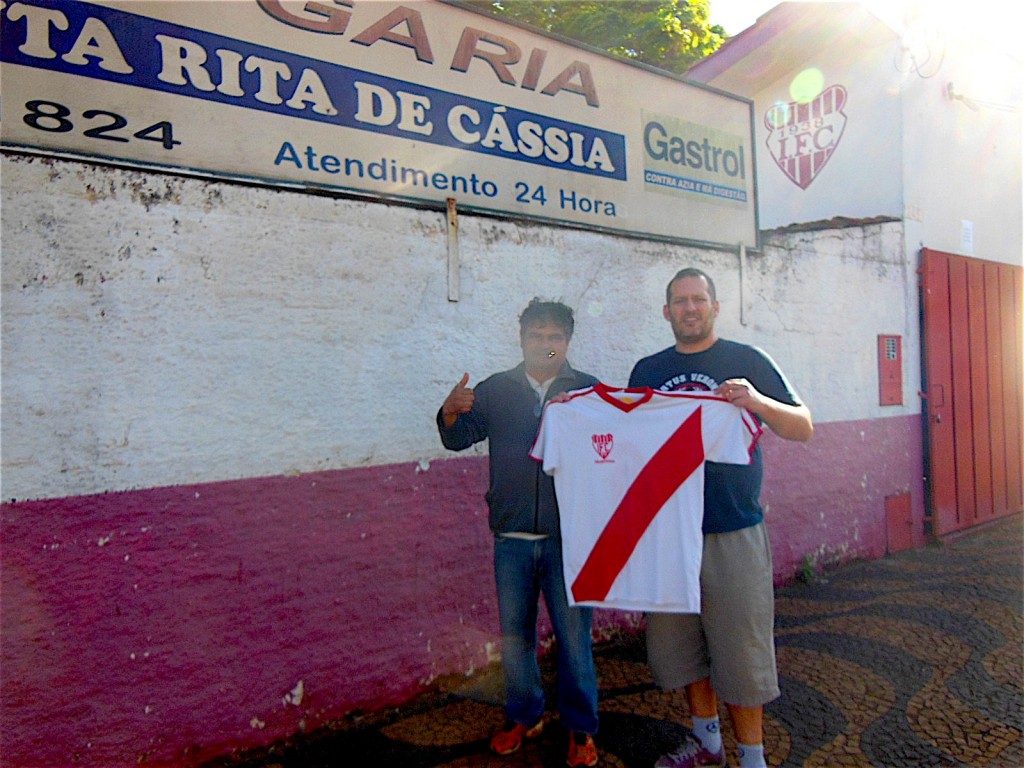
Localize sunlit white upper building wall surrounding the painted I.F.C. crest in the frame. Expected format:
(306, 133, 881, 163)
(709, 3, 1024, 264)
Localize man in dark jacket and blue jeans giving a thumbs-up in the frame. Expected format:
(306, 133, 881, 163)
(437, 299, 597, 766)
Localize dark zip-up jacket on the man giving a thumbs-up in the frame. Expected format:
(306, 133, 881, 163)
(437, 362, 597, 535)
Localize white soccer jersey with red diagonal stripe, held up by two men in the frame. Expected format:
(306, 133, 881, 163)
(530, 384, 761, 613)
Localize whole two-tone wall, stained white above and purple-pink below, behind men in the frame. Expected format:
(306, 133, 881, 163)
(0, 155, 923, 765)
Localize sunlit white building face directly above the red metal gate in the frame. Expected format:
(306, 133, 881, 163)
(902, 35, 1024, 264)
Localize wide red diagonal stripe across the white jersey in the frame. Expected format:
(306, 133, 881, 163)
(572, 409, 703, 602)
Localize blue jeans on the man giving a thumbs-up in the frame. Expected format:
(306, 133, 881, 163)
(495, 536, 597, 733)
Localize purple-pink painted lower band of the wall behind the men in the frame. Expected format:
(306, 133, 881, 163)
(0, 417, 924, 766)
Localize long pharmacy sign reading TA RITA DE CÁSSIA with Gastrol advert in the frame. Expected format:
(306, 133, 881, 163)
(0, 0, 757, 247)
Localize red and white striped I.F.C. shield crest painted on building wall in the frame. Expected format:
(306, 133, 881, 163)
(765, 85, 846, 189)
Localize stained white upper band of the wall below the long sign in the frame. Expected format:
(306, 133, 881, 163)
(0, 155, 919, 500)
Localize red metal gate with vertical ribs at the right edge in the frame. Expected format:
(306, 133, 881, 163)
(921, 249, 1024, 536)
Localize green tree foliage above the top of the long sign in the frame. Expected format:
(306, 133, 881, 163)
(468, 0, 726, 74)
